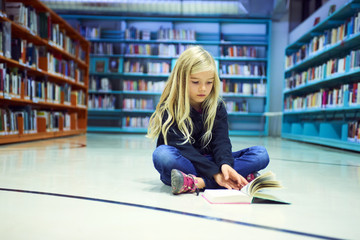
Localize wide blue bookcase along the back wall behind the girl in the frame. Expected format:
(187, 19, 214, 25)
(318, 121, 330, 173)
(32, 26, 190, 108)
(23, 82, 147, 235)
(61, 14, 271, 136)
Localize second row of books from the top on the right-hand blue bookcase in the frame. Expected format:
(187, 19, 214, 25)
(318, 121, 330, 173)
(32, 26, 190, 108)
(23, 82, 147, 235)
(285, 50, 360, 90)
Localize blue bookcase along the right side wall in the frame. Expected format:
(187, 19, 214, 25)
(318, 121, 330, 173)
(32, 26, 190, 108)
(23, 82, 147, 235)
(282, 1, 360, 151)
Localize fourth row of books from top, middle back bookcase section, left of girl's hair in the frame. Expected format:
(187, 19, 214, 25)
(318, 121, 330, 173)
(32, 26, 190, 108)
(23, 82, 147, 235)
(123, 79, 166, 92)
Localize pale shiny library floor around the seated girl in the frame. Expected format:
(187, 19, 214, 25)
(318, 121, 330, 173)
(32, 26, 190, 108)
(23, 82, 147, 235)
(0, 134, 360, 240)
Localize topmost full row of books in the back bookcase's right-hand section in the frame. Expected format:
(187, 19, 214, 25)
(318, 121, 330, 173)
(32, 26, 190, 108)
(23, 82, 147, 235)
(220, 45, 266, 58)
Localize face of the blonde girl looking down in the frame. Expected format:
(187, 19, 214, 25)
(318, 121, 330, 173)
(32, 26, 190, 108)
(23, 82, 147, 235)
(188, 71, 215, 111)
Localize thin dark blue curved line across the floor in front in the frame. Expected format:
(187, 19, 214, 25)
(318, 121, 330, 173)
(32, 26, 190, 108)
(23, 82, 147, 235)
(0, 188, 341, 240)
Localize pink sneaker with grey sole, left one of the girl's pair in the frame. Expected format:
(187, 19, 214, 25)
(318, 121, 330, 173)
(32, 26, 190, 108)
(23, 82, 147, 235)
(171, 169, 199, 195)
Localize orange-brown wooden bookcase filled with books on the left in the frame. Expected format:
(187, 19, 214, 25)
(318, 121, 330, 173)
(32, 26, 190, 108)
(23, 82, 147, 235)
(0, 0, 90, 144)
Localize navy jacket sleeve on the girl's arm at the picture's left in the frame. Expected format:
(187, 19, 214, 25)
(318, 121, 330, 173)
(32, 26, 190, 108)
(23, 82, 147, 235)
(160, 115, 220, 178)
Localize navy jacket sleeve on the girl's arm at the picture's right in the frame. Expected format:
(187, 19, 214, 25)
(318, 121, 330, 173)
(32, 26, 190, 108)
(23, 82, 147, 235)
(211, 102, 234, 169)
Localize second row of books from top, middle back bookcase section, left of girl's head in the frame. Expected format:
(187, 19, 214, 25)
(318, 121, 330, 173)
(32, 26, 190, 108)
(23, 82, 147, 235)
(125, 43, 192, 57)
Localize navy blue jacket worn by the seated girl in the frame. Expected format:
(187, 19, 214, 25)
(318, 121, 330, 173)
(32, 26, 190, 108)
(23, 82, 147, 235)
(157, 102, 234, 178)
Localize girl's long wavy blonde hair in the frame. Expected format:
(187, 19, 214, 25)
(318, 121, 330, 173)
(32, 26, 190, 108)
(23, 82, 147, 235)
(147, 46, 220, 148)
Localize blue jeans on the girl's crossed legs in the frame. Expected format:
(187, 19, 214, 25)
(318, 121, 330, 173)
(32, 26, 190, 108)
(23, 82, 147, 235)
(153, 145, 269, 189)
